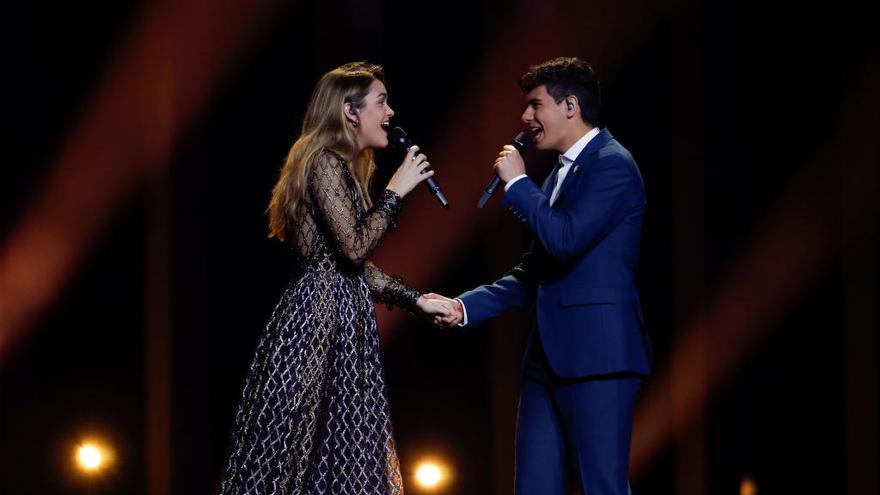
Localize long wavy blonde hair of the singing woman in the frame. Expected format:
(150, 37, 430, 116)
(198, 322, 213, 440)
(267, 62, 385, 241)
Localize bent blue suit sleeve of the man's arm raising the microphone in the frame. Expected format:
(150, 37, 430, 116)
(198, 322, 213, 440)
(504, 155, 639, 261)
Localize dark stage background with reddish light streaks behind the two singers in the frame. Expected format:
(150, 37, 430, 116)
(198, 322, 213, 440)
(0, 0, 880, 495)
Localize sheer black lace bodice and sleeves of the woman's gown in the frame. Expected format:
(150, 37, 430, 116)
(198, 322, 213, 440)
(290, 150, 420, 311)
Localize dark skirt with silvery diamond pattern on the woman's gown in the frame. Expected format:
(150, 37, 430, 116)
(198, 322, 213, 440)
(220, 266, 403, 495)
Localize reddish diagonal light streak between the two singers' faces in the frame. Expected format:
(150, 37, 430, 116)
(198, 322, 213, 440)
(375, 0, 668, 341)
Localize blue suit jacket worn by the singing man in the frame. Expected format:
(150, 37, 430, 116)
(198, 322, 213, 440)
(459, 129, 651, 377)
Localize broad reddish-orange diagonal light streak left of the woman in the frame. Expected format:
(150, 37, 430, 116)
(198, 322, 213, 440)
(0, 0, 292, 354)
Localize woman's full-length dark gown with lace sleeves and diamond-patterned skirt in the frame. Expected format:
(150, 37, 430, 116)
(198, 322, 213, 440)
(220, 151, 419, 495)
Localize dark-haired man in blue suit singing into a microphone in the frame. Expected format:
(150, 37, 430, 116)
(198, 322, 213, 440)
(431, 58, 651, 495)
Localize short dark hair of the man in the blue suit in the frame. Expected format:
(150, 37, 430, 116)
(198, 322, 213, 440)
(519, 57, 601, 127)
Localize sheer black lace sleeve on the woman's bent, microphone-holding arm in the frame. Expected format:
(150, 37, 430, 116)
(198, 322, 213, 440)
(309, 151, 402, 266)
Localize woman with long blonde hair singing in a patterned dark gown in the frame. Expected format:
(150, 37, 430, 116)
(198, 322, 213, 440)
(221, 62, 447, 495)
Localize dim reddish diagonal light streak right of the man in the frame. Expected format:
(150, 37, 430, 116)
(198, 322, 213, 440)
(630, 71, 878, 477)
